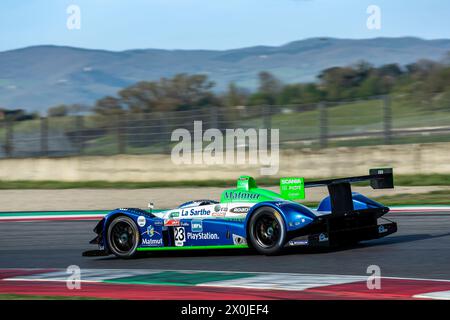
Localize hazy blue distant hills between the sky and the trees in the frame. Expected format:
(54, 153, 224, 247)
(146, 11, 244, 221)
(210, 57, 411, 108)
(0, 37, 450, 110)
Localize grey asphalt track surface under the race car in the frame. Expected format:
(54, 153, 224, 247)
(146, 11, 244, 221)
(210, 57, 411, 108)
(0, 213, 450, 279)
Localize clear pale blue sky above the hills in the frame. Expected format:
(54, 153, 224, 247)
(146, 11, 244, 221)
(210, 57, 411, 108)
(0, 0, 450, 51)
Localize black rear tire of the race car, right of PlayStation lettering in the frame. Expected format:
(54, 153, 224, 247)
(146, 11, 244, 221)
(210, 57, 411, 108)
(248, 207, 286, 255)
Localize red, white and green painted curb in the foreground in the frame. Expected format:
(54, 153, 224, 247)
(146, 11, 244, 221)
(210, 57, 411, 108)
(0, 269, 450, 300)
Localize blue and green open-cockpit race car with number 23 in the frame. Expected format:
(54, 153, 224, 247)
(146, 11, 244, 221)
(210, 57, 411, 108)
(84, 168, 397, 258)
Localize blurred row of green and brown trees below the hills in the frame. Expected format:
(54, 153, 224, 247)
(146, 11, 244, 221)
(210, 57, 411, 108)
(39, 56, 450, 116)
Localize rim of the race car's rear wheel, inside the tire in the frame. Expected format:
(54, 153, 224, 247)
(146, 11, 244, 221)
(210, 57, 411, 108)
(253, 213, 282, 248)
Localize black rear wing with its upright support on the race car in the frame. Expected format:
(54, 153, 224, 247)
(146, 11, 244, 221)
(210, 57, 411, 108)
(305, 168, 394, 214)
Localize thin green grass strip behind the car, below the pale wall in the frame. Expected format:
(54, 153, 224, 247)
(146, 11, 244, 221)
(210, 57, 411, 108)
(0, 174, 450, 189)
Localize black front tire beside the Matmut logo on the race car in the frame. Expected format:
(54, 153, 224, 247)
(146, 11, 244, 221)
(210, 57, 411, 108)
(106, 216, 140, 258)
